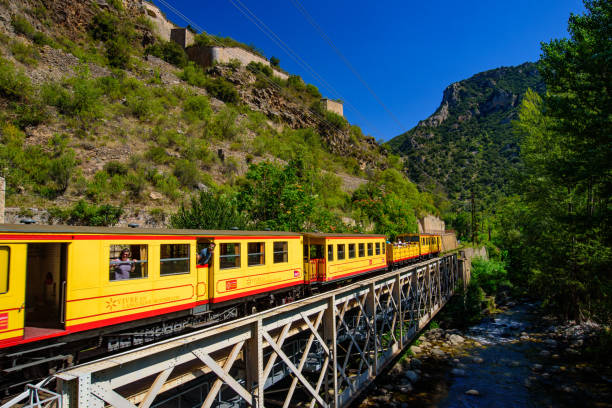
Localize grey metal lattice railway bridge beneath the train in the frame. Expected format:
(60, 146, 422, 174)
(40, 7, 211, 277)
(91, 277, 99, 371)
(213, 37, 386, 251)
(0, 254, 468, 408)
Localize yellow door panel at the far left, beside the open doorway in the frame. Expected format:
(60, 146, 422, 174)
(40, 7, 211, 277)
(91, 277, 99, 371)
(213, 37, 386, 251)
(0, 244, 26, 343)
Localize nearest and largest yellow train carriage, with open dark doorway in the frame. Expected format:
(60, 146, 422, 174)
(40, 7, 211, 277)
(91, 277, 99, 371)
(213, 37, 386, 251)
(0, 225, 304, 348)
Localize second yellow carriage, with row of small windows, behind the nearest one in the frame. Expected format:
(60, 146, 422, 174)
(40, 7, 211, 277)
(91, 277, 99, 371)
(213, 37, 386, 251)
(304, 233, 387, 283)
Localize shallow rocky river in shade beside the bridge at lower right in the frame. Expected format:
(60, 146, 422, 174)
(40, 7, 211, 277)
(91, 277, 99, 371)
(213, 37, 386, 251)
(356, 302, 612, 408)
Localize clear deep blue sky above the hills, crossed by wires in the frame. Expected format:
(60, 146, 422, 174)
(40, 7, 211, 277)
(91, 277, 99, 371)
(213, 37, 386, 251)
(154, 0, 584, 140)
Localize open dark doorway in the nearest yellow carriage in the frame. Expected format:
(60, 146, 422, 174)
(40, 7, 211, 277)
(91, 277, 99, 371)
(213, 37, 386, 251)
(24, 243, 68, 338)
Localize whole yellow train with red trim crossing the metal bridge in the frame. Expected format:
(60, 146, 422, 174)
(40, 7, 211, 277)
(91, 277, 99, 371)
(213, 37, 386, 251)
(0, 225, 439, 389)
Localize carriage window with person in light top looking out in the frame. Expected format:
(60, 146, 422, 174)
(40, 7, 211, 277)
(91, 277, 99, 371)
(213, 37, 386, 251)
(109, 244, 149, 281)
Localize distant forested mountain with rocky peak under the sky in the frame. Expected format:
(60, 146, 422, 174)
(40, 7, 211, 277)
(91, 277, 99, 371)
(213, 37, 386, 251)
(389, 63, 544, 206)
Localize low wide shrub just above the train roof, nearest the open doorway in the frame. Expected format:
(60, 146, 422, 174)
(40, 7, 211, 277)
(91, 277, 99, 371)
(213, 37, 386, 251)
(49, 200, 123, 226)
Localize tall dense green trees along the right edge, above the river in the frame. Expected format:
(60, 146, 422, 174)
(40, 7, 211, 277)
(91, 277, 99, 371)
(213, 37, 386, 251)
(515, 1, 612, 321)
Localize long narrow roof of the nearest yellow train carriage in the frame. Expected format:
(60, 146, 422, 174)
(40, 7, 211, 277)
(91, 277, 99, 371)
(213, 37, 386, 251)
(0, 224, 302, 237)
